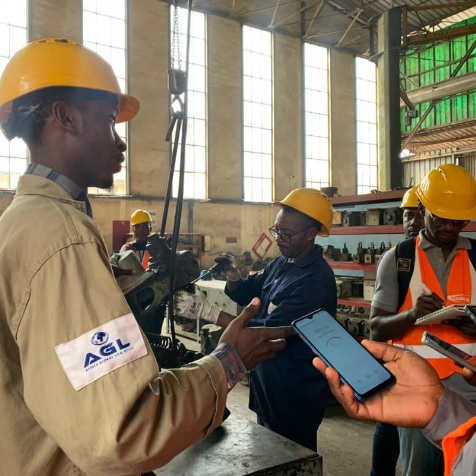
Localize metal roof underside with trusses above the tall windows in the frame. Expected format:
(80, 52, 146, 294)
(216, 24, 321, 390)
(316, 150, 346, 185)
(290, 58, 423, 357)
(166, 0, 476, 55)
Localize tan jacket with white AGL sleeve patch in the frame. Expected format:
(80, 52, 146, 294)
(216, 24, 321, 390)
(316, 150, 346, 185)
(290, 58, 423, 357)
(0, 175, 228, 476)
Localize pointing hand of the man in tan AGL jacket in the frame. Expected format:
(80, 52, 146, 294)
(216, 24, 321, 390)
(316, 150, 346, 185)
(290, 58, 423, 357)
(220, 298, 294, 370)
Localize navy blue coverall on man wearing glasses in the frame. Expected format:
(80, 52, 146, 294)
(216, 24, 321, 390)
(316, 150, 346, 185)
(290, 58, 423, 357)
(225, 246, 337, 451)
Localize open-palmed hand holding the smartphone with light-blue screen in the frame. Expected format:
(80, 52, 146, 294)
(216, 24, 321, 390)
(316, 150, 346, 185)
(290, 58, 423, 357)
(313, 340, 444, 428)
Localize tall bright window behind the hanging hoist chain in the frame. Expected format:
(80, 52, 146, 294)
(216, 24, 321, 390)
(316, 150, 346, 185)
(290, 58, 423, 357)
(170, 7, 207, 199)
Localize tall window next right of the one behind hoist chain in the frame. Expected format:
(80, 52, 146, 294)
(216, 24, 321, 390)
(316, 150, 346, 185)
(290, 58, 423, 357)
(243, 26, 273, 202)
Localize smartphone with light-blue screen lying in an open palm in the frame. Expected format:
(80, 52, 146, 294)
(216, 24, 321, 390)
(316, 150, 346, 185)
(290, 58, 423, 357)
(292, 309, 395, 402)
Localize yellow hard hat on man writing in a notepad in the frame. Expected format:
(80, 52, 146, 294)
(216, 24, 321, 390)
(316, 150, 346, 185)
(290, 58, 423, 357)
(416, 164, 476, 220)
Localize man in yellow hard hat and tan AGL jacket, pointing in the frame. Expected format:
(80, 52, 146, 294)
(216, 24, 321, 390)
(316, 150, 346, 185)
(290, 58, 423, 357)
(0, 38, 291, 476)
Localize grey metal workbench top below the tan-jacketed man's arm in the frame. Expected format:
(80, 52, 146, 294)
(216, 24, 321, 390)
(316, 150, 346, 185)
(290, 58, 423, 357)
(155, 414, 323, 476)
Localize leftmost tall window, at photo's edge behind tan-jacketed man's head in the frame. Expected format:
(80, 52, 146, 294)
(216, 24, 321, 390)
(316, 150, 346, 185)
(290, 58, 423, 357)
(0, 0, 28, 190)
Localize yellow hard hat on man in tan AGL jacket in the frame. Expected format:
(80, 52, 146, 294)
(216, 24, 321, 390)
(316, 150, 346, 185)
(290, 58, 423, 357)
(0, 38, 140, 124)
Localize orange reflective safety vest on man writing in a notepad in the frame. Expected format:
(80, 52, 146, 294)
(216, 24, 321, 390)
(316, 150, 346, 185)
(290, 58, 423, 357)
(393, 237, 476, 379)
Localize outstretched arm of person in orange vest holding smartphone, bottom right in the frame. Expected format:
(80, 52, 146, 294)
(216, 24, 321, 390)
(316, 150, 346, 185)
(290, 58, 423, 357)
(313, 340, 476, 476)
